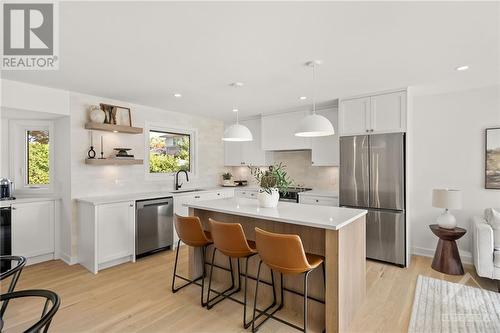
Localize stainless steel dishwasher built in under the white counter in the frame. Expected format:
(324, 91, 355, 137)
(135, 197, 174, 257)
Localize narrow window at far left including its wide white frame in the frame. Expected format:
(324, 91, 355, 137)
(9, 120, 54, 193)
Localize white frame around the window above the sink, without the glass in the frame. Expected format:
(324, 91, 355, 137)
(144, 122, 198, 180)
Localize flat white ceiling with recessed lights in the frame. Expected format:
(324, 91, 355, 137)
(2, 2, 500, 119)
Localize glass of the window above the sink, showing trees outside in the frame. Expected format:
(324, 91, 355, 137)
(149, 130, 193, 174)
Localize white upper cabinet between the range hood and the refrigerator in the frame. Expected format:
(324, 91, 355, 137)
(311, 109, 340, 166)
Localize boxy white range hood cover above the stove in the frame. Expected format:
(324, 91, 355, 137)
(262, 111, 311, 150)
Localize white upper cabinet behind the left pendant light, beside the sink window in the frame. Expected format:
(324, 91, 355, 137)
(224, 118, 272, 166)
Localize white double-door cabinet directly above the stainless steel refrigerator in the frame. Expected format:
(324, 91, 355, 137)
(339, 91, 407, 136)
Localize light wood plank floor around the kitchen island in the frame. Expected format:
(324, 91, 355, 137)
(1, 248, 496, 333)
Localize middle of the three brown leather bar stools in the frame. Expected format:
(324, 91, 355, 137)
(207, 219, 257, 328)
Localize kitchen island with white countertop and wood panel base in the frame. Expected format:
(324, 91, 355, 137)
(186, 198, 366, 332)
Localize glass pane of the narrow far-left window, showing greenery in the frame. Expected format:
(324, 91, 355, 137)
(25, 130, 50, 186)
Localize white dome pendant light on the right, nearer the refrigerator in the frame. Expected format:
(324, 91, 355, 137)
(295, 60, 335, 137)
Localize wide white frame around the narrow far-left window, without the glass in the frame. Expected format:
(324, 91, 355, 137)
(9, 120, 55, 194)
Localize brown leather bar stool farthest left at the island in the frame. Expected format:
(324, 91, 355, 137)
(172, 214, 213, 306)
